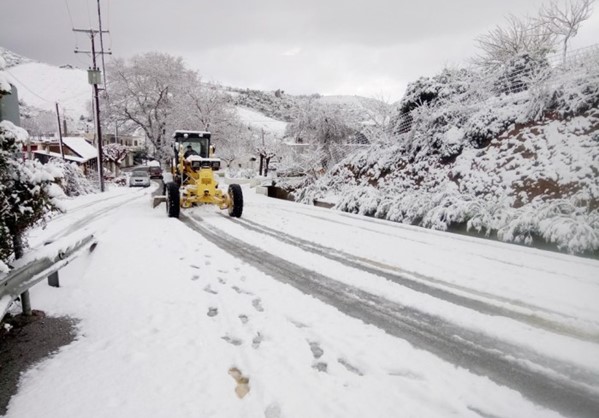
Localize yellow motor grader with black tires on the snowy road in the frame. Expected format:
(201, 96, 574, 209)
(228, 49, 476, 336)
(160, 130, 243, 218)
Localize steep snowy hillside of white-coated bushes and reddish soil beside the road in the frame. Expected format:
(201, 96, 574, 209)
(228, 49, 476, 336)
(299, 49, 599, 255)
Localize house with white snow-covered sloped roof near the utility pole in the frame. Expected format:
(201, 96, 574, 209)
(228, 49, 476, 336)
(33, 136, 98, 174)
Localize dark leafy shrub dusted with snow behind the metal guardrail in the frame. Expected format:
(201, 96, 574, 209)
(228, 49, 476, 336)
(0, 121, 58, 262)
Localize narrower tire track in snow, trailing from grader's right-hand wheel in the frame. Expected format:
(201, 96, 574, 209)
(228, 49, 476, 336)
(221, 215, 599, 343)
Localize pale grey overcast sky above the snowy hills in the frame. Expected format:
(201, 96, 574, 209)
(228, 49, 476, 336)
(0, 0, 599, 100)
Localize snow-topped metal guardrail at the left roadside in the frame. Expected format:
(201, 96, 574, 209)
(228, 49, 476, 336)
(0, 235, 97, 320)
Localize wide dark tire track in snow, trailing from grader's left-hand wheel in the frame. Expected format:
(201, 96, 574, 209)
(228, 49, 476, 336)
(181, 214, 599, 417)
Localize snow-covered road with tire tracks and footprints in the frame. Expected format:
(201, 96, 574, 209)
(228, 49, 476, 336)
(1, 186, 599, 418)
